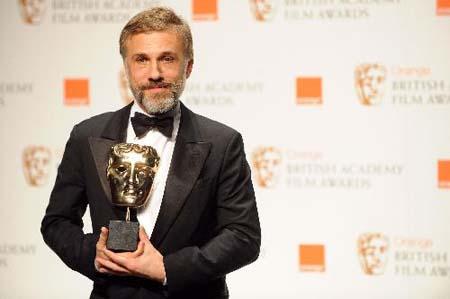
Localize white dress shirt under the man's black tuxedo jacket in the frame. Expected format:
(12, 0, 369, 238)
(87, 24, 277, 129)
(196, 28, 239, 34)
(127, 103, 181, 236)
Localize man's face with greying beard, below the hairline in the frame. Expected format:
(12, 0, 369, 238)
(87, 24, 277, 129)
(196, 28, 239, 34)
(124, 30, 192, 114)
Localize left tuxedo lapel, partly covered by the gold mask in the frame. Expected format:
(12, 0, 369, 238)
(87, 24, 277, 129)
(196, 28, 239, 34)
(88, 104, 132, 202)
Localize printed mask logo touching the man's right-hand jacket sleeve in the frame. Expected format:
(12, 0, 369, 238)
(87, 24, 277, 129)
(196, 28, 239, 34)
(252, 147, 281, 188)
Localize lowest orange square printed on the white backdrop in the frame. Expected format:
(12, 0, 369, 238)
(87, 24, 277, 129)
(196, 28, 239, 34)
(299, 244, 325, 272)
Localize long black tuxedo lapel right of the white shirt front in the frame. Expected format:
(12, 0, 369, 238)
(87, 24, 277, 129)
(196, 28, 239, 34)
(150, 104, 211, 246)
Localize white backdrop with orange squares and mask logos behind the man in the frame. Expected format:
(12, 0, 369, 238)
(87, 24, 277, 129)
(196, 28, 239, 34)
(0, 0, 450, 299)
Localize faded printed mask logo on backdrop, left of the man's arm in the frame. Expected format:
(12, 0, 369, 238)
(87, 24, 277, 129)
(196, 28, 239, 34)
(22, 146, 51, 187)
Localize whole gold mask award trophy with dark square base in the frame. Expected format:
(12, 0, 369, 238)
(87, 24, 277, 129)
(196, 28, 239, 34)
(106, 143, 160, 252)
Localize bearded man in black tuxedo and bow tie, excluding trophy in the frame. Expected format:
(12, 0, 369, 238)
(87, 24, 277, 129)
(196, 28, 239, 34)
(41, 8, 260, 298)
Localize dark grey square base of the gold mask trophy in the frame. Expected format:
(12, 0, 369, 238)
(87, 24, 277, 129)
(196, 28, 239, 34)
(106, 220, 139, 252)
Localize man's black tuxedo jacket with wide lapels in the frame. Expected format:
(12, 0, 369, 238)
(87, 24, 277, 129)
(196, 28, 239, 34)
(41, 104, 260, 298)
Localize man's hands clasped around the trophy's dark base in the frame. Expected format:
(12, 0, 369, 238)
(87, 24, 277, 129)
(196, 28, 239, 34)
(95, 227, 166, 283)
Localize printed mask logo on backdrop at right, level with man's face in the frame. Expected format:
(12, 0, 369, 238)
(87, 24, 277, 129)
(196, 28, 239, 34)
(355, 64, 386, 105)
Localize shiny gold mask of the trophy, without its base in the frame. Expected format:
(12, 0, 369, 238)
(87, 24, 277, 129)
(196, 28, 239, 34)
(107, 143, 160, 208)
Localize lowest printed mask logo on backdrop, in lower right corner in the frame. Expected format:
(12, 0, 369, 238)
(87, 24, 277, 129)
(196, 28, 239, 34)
(358, 233, 389, 275)
